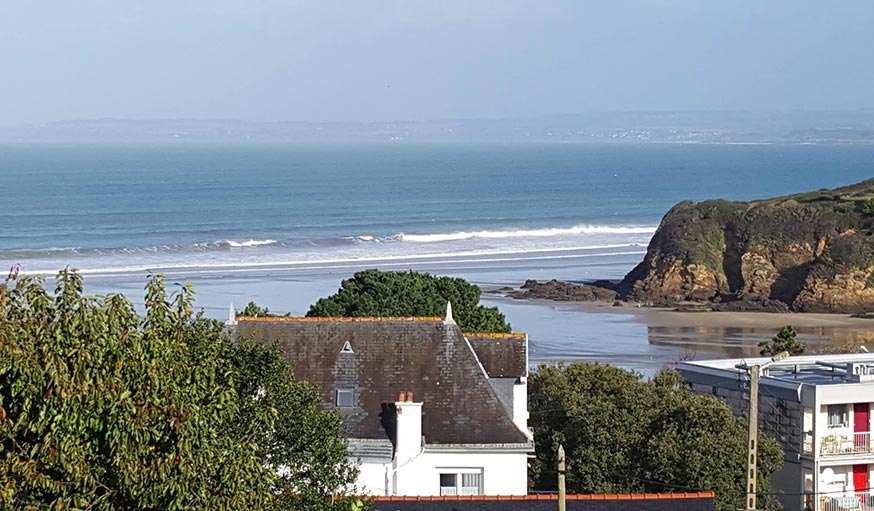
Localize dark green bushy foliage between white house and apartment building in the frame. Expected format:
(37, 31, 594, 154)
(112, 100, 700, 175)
(529, 363, 783, 511)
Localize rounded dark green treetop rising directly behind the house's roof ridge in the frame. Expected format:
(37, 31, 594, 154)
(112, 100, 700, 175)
(307, 270, 510, 332)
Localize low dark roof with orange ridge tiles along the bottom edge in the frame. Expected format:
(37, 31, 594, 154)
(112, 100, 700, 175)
(373, 493, 716, 511)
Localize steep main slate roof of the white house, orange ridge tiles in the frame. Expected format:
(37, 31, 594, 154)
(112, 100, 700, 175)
(234, 318, 530, 444)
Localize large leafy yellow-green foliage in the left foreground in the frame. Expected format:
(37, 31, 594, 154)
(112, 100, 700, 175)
(0, 270, 360, 510)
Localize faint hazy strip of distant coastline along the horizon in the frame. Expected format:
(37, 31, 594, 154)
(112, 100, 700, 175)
(0, 110, 874, 145)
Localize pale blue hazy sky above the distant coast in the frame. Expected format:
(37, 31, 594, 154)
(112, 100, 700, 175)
(0, 0, 874, 124)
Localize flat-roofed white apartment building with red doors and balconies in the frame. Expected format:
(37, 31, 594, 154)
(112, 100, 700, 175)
(677, 353, 874, 511)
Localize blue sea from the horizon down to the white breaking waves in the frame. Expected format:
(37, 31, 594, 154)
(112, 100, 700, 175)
(0, 144, 874, 274)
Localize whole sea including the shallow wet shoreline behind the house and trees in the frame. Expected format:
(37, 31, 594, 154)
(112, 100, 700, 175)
(0, 143, 874, 374)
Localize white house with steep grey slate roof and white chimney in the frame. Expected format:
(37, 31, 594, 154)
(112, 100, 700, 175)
(228, 306, 534, 496)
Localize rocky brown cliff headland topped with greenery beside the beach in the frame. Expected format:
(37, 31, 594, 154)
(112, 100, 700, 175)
(619, 179, 874, 313)
